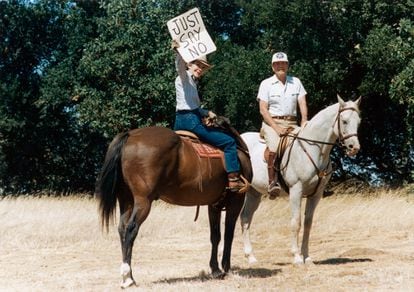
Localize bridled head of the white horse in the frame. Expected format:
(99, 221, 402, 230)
(335, 95, 361, 156)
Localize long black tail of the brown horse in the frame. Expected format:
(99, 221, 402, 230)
(95, 132, 129, 231)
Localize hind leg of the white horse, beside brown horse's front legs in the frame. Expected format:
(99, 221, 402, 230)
(240, 188, 261, 264)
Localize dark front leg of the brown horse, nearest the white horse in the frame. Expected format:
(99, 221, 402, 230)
(221, 194, 244, 273)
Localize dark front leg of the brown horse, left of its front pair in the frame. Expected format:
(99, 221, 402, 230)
(208, 205, 223, 278)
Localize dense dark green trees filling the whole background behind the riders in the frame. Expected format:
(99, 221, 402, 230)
(0, 0, 414, 192)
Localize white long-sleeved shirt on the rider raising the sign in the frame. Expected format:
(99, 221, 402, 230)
(175, 53, 201, 111)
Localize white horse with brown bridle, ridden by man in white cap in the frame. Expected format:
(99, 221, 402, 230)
(240, 95, 361, 264)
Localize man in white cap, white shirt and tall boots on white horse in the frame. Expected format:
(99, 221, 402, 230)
(257, 52, 308, 199)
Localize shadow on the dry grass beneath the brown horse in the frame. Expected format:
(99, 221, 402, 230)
(153, 267, 282, 284)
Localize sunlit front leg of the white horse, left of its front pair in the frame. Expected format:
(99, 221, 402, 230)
(289, 187, 303, 264)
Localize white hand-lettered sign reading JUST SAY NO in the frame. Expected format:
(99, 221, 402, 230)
(167, 8, 216, 63)
